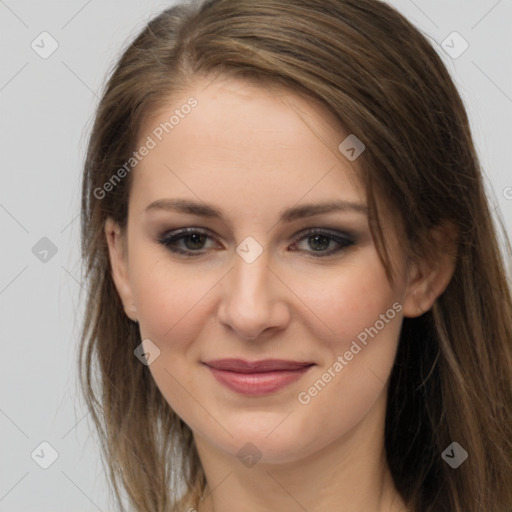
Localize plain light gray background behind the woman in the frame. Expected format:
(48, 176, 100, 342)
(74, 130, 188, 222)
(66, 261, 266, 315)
(0, 0, 512, 512)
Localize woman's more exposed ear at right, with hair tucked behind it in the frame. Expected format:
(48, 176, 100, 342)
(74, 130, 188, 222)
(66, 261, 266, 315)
(403, 222, 458, 318)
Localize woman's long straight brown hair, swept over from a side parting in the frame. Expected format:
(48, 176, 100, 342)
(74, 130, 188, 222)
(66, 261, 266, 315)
(79, 0, 512, 512)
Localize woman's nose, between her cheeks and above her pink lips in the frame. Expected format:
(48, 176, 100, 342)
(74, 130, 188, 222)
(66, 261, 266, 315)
(218, 250, 290, 340)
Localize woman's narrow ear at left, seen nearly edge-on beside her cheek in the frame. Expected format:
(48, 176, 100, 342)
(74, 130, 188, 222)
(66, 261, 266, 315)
(105, 217, 137, 322)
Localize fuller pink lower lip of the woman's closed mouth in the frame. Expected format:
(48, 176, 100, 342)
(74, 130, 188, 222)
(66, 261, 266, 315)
(208, 366, 311, 396)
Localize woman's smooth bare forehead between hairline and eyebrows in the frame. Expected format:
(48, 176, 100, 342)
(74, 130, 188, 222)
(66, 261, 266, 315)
(133, 78, 363, 217)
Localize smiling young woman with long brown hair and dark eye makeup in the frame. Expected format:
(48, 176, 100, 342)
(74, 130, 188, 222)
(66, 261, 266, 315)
(80, 0, 512, 512)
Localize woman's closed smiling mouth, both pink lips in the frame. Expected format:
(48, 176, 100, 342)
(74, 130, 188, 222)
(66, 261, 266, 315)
(203, 359, 315, 396)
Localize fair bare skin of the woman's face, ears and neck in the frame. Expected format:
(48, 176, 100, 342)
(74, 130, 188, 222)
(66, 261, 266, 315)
(105, 78, 453, 512)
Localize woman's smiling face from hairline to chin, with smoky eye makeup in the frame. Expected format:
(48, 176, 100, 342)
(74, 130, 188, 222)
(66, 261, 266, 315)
(107, 79, 428, 462)
